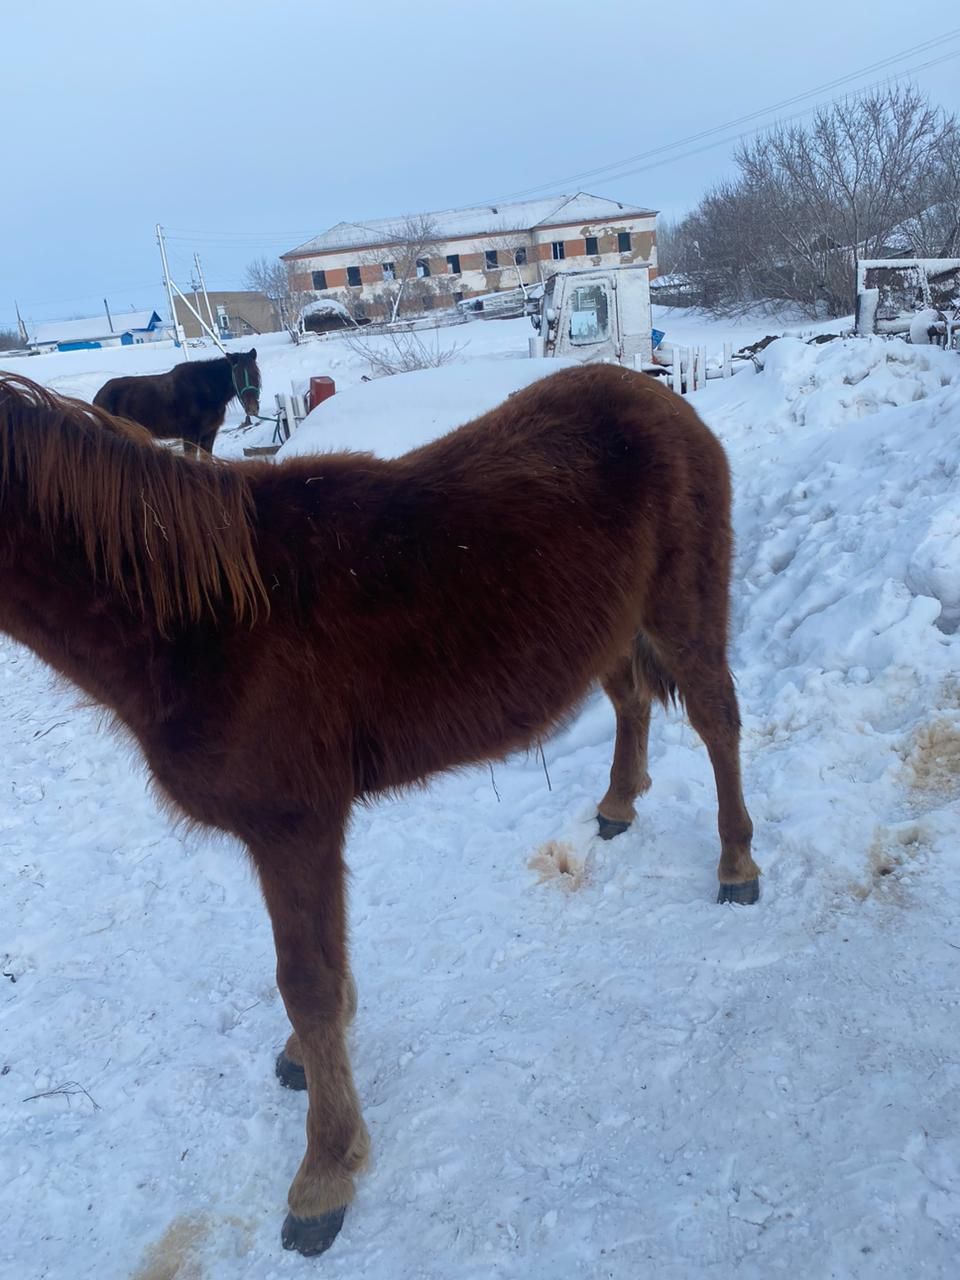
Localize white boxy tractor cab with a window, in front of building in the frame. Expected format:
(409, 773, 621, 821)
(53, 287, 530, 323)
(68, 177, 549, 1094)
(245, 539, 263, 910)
(530, 266, 662, 372)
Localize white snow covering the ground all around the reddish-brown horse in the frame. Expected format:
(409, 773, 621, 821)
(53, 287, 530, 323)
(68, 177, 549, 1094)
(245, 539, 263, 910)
(0, 314, 960, 1280)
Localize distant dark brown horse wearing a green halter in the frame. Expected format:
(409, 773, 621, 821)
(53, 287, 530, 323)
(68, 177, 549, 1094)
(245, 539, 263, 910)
(93, 348, 260, 453)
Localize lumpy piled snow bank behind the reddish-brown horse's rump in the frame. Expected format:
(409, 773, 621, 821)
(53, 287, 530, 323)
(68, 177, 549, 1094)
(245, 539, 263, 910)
(698, 338, 960, 911)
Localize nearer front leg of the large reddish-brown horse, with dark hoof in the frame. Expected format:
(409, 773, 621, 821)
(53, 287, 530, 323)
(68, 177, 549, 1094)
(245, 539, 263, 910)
(252, 823, 369, 1254)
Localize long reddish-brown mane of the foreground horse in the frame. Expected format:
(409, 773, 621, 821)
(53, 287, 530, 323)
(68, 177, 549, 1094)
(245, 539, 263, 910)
(0, 374, 268, 631)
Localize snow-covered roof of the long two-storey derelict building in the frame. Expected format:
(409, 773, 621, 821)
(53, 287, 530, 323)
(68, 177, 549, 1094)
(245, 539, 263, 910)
(282, 191, 654, 257)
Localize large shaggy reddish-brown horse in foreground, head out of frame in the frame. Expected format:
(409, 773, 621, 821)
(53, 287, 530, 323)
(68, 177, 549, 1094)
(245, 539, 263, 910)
(0, 365, 759, 1253)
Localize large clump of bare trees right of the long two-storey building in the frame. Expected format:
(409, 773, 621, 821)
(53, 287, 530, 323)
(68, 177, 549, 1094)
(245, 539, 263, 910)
(659, 87, 960, 316)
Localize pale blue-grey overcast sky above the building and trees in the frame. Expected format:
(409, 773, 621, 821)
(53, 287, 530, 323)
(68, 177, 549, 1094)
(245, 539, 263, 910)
(0, 0, 960, 328)
